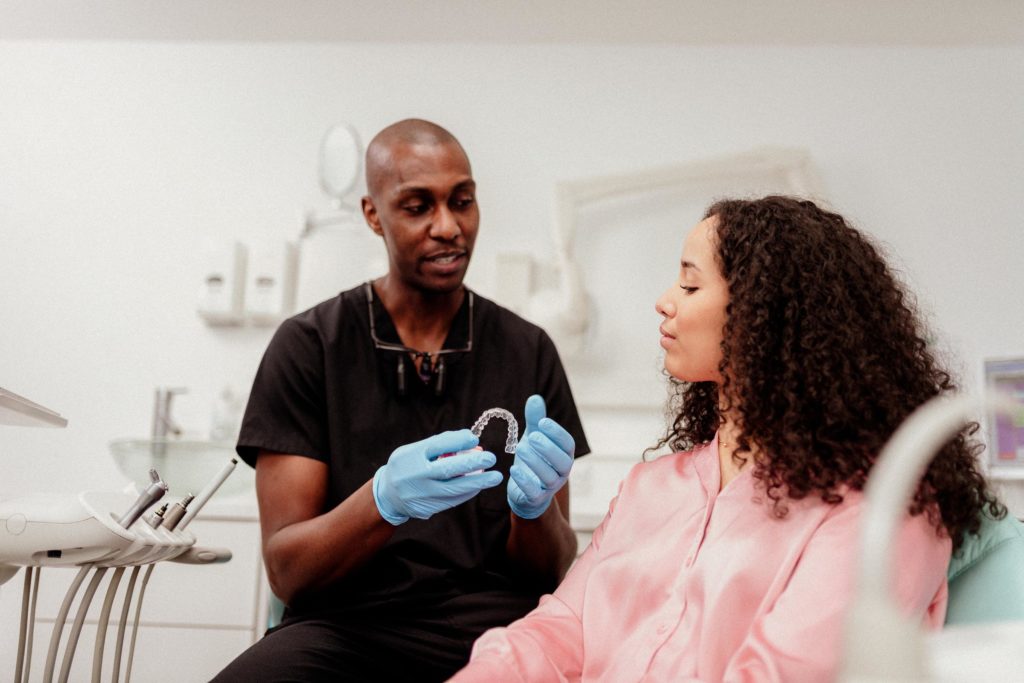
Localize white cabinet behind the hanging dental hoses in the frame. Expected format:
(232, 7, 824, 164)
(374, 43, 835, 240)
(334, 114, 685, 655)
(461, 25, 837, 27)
(0, 502, 266, 681)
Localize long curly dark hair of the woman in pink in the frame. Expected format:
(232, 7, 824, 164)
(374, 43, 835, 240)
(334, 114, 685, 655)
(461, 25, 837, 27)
(654, 197, 1006, 548)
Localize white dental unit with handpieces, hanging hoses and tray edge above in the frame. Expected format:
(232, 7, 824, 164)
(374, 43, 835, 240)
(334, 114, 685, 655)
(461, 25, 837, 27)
(0, 388, 237, 683)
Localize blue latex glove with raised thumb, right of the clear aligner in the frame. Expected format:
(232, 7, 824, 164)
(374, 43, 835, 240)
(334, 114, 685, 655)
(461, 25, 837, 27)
(509, 394, 575, 519)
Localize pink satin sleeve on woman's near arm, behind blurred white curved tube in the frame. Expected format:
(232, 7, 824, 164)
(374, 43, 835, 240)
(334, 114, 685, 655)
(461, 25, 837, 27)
(723, 505, 950, 683)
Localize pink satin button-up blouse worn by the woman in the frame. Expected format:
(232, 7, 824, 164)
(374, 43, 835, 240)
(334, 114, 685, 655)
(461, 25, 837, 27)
(453, 438, 951, 683)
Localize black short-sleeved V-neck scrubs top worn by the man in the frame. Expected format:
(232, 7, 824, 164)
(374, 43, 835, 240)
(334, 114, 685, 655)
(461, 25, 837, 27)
(238, 285, 590, 637)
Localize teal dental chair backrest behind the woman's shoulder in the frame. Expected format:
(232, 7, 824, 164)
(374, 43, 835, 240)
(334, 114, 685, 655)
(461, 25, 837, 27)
(946, 514, 1024, 626)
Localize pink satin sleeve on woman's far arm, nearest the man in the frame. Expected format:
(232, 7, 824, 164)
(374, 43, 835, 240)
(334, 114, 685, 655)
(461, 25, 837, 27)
(452, 484, 622, 683)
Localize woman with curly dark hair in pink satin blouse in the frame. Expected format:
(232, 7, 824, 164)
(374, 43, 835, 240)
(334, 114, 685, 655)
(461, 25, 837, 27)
(453, 197, 1005, 683)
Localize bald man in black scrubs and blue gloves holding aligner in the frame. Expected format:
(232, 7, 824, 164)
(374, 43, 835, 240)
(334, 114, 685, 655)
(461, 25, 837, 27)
(216, 120, 589, 681)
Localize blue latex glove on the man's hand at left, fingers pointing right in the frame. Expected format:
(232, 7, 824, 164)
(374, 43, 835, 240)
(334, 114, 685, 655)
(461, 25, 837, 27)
(373, 429, 502, 526)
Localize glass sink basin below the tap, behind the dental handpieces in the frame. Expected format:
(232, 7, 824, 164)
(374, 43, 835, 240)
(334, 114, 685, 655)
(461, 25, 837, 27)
(111, 438, 256, 501)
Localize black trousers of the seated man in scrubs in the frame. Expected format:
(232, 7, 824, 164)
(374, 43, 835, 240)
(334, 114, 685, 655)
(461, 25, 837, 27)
(213, 616, 475, 683)
